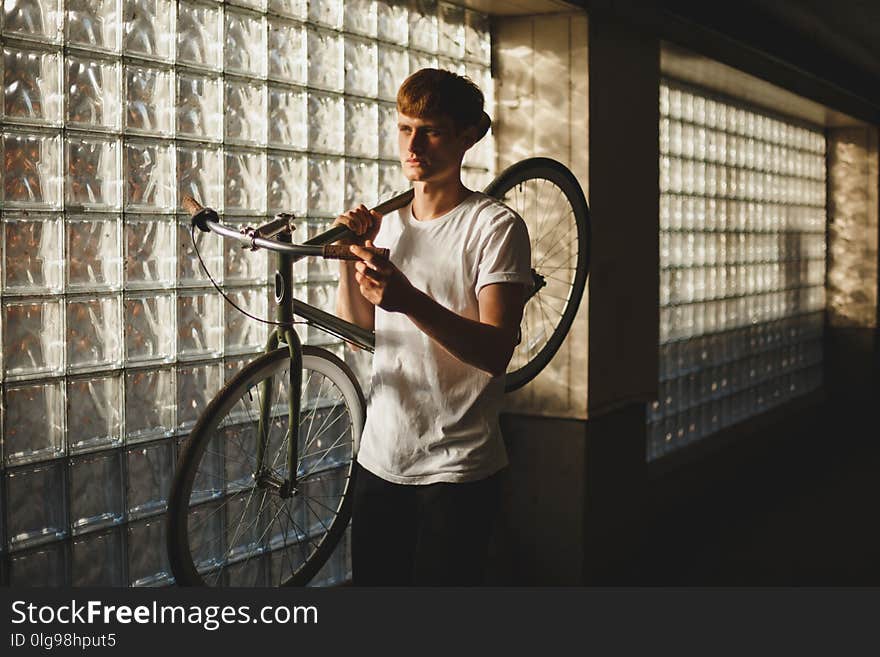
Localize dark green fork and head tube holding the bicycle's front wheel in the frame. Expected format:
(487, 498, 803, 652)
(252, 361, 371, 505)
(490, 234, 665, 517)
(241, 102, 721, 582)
(254, 233, 302, 499)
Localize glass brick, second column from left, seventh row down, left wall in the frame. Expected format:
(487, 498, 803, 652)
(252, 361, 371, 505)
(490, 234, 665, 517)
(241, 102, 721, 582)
(69, 450, 123, 534)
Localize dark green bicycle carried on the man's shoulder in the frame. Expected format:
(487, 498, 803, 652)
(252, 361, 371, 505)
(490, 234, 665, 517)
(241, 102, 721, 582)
(167, 158, 590, 586)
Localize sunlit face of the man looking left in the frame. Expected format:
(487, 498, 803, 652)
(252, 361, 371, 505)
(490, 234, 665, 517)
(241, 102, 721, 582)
(397, 112, 471, 182)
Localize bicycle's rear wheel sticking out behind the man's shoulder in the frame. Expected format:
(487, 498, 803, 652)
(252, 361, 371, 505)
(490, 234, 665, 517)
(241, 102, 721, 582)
(485, 157, 590, 392)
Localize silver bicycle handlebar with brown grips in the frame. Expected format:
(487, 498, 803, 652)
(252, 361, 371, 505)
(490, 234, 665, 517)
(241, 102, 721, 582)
(181, 189, 413, 260)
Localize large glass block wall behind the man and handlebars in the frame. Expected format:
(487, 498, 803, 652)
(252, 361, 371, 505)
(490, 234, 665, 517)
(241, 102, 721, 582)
(0, 0, 494, 586)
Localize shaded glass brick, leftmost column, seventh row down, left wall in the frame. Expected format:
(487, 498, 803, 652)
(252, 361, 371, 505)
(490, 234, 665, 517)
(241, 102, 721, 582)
(6, 462, 67, 550)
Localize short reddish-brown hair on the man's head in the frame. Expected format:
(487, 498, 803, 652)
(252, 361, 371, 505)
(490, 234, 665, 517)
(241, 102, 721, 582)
(397, 68, 491, 139)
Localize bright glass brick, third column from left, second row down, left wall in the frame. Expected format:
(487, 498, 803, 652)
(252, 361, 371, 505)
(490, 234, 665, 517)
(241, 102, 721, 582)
(125, 66, 174, 136)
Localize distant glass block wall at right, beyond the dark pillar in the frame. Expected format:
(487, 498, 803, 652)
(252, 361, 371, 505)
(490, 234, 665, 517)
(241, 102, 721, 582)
(647, 80, 826, 460)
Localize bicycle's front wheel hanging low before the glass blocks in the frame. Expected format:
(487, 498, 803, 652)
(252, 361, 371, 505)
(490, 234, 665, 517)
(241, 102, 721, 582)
(168, 346, 365, 586)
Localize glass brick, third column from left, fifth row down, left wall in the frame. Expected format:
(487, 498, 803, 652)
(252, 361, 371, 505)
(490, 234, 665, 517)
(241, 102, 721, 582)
(123, 294, 176, 363)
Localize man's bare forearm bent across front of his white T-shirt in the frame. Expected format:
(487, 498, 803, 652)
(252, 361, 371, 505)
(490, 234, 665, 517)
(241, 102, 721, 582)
(406, 289, 516, 376)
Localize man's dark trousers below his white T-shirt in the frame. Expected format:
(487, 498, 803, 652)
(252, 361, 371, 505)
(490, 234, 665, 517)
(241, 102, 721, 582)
(351, 465, 501, 586)
